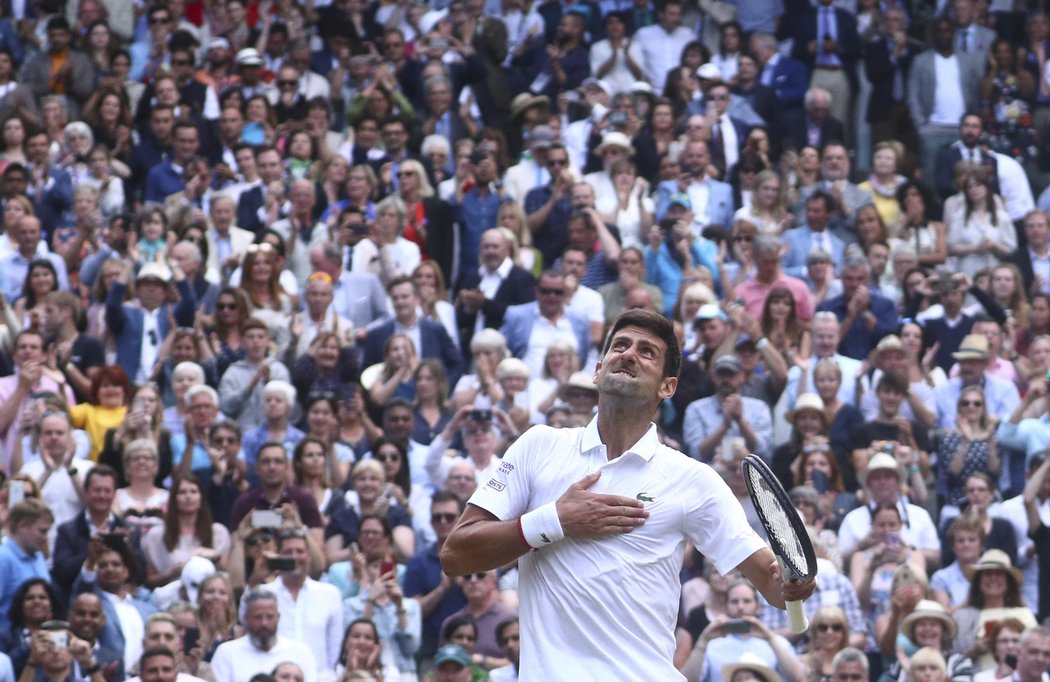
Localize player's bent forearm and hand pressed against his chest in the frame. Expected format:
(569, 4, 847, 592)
(441, 471, 649, 576)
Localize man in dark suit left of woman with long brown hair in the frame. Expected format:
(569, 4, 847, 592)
(51, 464, 128, 603)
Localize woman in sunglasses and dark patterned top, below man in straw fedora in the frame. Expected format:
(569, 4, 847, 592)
(937, 386, 1003, 515)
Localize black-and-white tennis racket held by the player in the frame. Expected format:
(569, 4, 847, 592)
(740, 454, 817, 635)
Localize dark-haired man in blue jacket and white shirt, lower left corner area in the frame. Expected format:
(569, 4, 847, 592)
(72, 535, 156, 669)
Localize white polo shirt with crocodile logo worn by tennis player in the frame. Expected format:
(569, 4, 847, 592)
(470, 418, 765, 682)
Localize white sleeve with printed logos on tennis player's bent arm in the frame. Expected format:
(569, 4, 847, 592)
(469, 426, 557, 520)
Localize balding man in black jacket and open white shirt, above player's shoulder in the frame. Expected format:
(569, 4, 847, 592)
(456, 228, 536, 348)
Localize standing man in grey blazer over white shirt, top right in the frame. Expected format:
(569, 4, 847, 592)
(908, 17, 985, 189)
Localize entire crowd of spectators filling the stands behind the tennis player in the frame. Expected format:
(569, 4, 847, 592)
(8, 0, 1050, 682)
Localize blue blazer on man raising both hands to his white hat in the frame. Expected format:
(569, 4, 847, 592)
(106, 278, 196, 381)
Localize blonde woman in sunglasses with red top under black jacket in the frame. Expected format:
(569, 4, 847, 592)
(397, 158, 455, 281)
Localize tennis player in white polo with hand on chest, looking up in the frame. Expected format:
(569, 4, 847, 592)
(441, 310, 815, 682)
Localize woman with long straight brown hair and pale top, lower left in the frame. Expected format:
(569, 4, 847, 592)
(142, 474, 230, 589)
